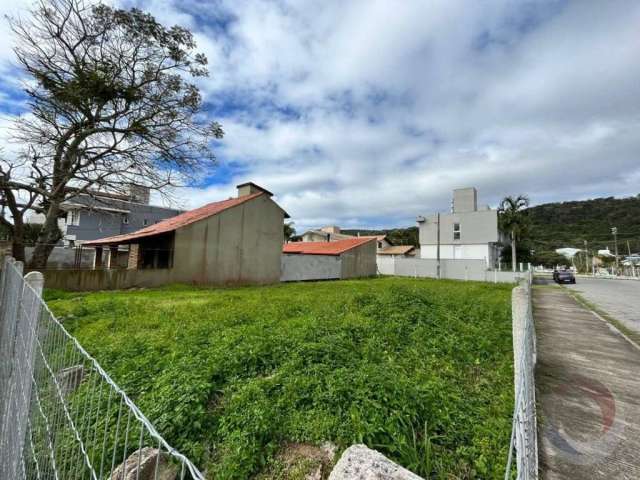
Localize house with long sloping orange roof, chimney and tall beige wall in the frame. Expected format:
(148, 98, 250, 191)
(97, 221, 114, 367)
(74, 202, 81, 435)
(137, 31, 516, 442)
(85, 182, 289, 284)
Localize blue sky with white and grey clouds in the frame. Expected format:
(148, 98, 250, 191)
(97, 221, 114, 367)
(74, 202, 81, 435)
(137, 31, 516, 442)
(0, 0, 640, 231)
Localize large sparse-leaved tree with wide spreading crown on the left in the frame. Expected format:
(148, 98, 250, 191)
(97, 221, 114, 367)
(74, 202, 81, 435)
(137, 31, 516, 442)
(0, 0, 223, 268)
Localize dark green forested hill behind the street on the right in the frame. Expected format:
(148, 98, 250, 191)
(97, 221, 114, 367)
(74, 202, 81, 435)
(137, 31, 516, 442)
(528, 195, 640, 254)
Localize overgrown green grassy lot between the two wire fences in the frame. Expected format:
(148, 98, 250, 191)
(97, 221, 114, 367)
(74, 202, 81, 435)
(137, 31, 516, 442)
(48, 278, 513, 479)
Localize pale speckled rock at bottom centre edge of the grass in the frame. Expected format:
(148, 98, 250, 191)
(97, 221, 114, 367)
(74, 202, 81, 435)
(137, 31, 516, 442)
(329, 445, 423, 480)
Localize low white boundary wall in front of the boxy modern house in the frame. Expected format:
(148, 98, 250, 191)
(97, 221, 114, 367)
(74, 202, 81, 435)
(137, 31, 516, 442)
(377, 257, 526, 283)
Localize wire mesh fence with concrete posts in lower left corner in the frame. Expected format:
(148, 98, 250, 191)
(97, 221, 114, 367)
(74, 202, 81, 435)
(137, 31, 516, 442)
(0, 257, 204, 480)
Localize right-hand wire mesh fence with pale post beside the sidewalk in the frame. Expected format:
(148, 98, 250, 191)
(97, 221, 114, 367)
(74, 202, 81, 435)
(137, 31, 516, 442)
(504, 272, 538, 480)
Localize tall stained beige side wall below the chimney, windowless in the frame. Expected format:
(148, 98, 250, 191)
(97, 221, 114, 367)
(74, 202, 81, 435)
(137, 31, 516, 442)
(172, 195, 284, 285)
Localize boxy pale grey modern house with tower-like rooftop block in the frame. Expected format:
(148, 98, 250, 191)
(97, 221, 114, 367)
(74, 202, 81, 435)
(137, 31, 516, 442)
(417, 188, 508, 268)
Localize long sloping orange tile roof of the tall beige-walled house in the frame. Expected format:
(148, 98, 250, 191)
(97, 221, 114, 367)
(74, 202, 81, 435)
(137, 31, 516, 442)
(83, 192, 264, 246)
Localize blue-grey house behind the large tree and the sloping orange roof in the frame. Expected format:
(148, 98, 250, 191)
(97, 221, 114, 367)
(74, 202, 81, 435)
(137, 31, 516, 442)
(28, 185, 182, 247)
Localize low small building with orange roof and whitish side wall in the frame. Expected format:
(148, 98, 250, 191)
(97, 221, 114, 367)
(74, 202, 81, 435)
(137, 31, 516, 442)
(281, 237, 377, 282)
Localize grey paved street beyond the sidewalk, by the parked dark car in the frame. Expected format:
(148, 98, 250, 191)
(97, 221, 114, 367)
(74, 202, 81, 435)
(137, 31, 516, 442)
(569, 278, 640, 333)
